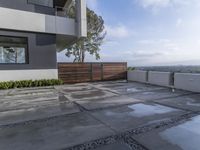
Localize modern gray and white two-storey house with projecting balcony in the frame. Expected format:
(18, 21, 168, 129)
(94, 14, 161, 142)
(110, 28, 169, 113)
(0, 0, 87, 82)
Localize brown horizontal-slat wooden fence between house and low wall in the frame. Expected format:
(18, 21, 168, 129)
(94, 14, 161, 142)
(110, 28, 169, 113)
(58, 63, 127, 83)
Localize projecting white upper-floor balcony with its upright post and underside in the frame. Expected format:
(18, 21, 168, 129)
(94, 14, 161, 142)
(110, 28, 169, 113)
(0, 0, 87, 51)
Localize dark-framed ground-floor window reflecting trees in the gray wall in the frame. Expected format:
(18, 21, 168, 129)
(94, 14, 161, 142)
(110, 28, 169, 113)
(0, 36, 28, 64)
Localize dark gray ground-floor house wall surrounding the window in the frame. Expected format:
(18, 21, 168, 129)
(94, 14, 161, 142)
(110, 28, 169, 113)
(0, 30, 57, 70)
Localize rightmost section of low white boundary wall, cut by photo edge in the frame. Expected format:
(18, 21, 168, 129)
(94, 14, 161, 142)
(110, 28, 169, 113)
(174, 73, 200, 92)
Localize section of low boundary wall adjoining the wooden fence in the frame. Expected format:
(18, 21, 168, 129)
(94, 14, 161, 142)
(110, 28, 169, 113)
(128, 70, 148, 83)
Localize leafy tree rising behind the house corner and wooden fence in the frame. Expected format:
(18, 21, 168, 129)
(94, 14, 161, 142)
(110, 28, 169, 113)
(66, 8, 106, 62)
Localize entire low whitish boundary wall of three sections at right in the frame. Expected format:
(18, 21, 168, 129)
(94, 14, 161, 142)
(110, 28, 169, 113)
(128, 70, 200, 93)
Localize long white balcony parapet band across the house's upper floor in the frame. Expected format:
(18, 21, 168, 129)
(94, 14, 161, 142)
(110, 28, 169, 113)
(0, 7, 76, 36)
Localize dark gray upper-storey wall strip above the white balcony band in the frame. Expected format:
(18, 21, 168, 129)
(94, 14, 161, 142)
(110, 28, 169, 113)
(0, 0, 55, 15)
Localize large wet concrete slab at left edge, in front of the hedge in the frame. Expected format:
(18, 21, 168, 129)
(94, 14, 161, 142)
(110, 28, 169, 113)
(0, 95, 80, 125)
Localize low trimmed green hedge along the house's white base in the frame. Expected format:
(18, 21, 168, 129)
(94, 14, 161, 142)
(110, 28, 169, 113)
(0, 79, 63, 89)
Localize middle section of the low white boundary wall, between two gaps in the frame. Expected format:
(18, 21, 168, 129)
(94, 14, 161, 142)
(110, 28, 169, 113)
(148, 71, 173, 87)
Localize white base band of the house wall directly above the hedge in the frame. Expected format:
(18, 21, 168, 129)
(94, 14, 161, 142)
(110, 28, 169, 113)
(0, 69, 58, 82)
